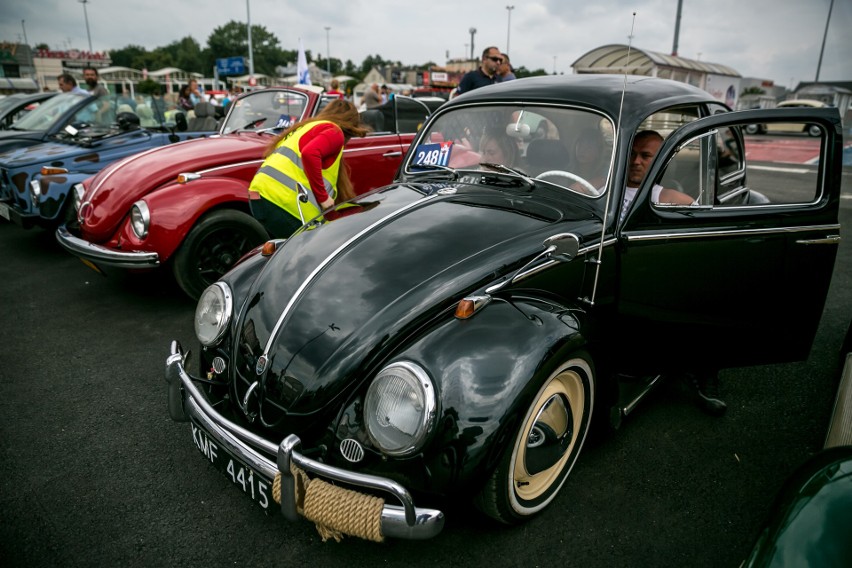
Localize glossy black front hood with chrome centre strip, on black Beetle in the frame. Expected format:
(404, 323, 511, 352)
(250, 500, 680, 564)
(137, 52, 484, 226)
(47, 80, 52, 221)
(230, 185, 594, 427)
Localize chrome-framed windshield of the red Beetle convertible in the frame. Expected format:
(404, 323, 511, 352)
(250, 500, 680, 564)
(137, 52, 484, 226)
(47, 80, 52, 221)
(222, 90, 308, 134)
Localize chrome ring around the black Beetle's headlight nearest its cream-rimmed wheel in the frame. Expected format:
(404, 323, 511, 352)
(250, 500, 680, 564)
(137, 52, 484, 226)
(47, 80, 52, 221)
(364, 361, 438, 457)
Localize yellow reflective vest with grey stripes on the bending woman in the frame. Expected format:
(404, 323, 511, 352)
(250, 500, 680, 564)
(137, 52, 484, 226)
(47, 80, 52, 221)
(249, 120, 343, 221)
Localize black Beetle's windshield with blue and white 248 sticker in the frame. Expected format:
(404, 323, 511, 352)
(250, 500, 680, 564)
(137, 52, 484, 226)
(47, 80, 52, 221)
(406, 104, 613, 195)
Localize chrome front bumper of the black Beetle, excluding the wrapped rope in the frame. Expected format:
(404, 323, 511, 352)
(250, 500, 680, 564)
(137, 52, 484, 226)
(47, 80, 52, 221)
(166, 341, 444, 540)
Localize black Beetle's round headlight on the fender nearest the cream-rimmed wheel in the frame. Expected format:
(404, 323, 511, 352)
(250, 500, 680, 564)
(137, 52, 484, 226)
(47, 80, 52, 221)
(364, 361, 436, 456)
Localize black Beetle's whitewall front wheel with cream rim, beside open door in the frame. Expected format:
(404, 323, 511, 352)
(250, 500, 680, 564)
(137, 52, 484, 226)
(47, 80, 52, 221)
(474, 353, 595, 524)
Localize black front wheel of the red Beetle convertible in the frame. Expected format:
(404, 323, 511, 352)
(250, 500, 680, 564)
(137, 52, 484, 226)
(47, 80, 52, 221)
(172, 209, 269, 299)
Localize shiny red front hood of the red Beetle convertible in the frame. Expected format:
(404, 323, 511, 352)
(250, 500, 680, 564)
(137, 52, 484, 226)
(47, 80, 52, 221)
(81, 132, 271, 242)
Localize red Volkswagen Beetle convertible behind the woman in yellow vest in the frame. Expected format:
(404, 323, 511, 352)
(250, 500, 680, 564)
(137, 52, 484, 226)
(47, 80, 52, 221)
(56, 86, 442, 297)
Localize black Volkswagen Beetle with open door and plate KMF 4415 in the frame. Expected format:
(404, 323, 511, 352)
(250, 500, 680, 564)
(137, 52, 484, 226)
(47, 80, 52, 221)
(166, 75, 842, 540)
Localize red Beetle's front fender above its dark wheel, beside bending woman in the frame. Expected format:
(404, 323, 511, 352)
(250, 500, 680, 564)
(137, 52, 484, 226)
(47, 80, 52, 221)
(133, 178, 249, 262)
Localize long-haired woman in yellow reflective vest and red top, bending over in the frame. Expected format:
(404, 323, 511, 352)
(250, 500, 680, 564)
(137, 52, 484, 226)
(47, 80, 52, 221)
(249, 99, 368, 238)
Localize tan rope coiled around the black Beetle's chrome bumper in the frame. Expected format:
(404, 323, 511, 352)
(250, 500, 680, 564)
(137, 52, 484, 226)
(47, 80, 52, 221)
(272, 464, 385, 542)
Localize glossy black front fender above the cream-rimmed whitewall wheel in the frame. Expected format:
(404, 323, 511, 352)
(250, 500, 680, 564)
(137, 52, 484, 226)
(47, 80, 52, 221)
(382, 295, 586, 487)
